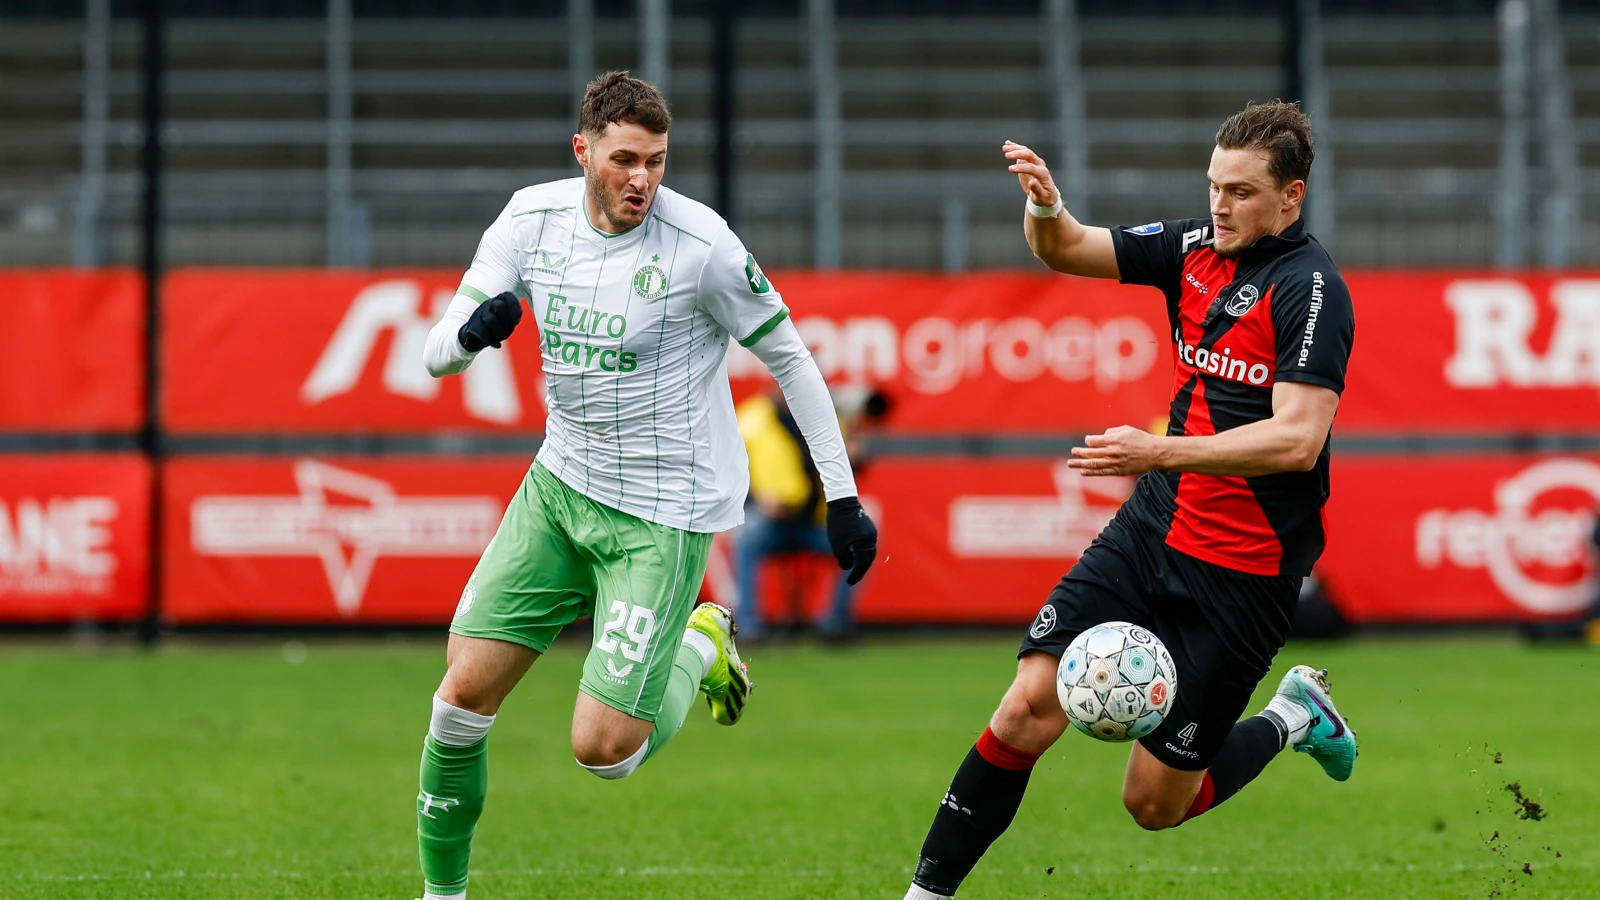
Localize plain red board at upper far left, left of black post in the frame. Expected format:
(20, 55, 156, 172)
(0, 269, 144, 431)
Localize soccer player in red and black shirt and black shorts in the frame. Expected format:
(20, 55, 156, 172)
(906, 102, 1355, 900)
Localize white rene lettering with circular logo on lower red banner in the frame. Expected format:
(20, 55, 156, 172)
(1416, 458, 1600, 615)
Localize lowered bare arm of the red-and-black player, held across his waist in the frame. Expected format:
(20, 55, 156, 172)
(1067, 381, 1339, 477)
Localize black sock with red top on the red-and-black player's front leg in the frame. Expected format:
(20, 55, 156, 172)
(912, 729, 1042, 897)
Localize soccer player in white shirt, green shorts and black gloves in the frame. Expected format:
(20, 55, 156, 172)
(406, 72, 877, 900)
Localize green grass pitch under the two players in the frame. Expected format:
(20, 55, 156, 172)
(0, 637, 1600, 900)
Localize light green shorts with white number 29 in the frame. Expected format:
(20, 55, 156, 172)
(450, 463, 712, 722)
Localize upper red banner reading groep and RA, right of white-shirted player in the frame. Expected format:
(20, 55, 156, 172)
(745, 272, 1600, 434)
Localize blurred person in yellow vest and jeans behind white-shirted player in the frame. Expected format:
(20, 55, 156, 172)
(734, 386, 888, 641)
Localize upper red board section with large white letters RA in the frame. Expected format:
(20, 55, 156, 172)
(1338, 274, 1600, 434)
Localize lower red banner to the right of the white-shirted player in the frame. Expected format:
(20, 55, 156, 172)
(707, 455, 1600, 623)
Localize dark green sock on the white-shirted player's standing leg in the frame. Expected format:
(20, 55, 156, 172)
(416, 735, 490, 894)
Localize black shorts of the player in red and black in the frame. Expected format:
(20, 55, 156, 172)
(1018, 504, 1301, 770)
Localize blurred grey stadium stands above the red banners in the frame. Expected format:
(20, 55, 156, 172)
(0, 6, 1600, 269)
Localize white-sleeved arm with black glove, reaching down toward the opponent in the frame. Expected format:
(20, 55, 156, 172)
(750, 319, 878, 585)
